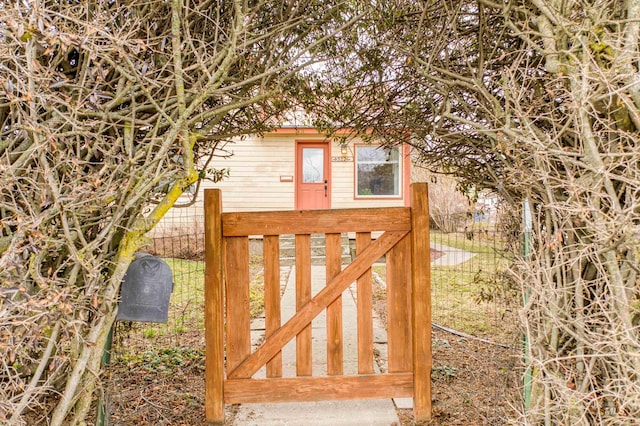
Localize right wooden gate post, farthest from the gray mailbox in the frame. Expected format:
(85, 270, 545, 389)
(411, 183, 432, 422)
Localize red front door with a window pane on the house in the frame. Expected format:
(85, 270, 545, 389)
(296, 142, 331, 210)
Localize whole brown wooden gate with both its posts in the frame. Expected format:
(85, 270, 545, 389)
(205, 183, 432, 424)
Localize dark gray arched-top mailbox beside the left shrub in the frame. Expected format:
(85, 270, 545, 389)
(116, 255, 173, 322)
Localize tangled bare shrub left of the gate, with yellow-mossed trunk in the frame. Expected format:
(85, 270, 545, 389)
(0, 0, 356, 425)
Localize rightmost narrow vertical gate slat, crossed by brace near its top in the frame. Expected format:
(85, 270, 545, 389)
(356, 232, 373, 374)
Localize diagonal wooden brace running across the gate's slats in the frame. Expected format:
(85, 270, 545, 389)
(227, 231, 409, 379)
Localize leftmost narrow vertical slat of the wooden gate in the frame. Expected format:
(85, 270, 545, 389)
(263, 235, 282, 377)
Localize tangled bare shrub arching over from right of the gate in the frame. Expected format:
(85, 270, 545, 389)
(308, 0, 640, 425)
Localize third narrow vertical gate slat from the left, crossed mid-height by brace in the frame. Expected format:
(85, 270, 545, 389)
(325, 234, 344, 376)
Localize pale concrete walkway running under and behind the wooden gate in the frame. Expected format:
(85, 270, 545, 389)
(233, 265, 400, 426)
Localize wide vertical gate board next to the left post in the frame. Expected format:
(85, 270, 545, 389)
(224, 237, 251, 378)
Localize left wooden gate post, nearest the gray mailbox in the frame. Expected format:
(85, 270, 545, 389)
(204, 189, 224, 425)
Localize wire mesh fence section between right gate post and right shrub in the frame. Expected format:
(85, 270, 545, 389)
(424, 214, 522, 425)
